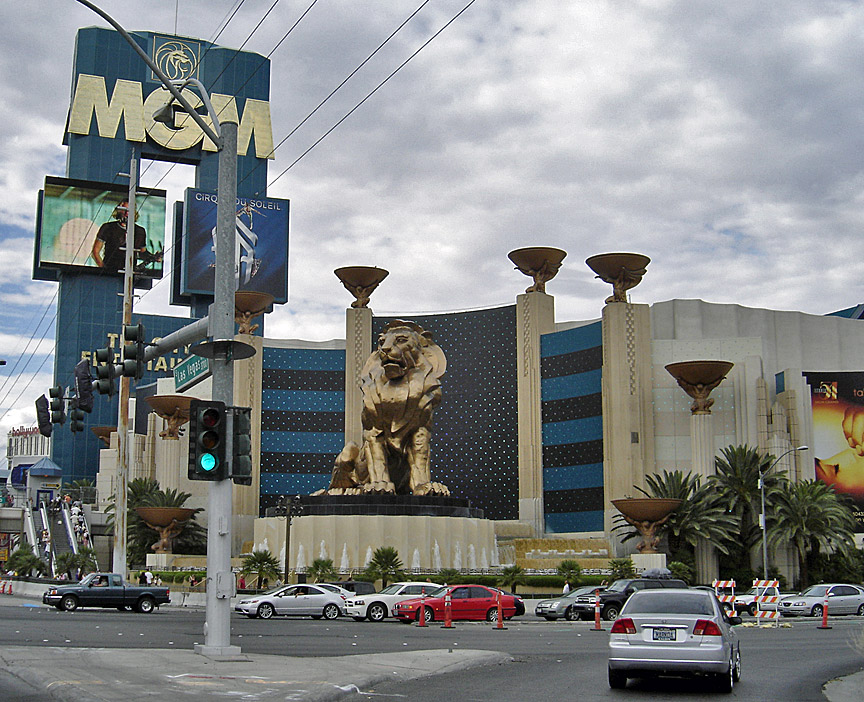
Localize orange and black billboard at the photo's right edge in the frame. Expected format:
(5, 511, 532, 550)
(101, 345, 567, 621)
(804, 372, 864, 532)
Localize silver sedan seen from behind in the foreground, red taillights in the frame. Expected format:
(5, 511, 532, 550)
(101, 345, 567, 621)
(609, 589, 741, 692)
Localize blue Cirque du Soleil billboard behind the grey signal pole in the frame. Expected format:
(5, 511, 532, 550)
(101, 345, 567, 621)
(181, 188, 290, 303)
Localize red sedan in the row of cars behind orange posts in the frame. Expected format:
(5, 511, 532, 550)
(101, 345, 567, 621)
(393, 585, 525, 624)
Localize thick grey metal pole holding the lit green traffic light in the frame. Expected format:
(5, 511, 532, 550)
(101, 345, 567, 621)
(195, 121, 240, 656)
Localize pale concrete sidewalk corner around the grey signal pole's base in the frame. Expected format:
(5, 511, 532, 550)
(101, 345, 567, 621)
(0, 646, 510, 702)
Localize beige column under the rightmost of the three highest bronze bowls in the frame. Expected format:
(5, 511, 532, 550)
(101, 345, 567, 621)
(602, 302, 654, 534)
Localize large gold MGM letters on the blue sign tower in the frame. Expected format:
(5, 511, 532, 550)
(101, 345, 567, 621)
(68, 73, 275, 159)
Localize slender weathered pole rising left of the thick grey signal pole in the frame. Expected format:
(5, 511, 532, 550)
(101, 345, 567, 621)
(112, 151, 138, 577)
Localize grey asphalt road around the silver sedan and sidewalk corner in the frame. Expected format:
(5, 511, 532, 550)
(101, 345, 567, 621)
(0, 602, 864, 702)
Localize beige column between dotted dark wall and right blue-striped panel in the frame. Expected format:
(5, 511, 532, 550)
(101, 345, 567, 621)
(516, 292, 555, 536)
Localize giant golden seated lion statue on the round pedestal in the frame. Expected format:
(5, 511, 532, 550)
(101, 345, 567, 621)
(317, 320, 450, 496)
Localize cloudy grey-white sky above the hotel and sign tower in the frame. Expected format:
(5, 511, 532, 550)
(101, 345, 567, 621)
(0, 0, 864, 440)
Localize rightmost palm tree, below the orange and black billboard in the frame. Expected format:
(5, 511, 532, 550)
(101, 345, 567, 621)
(768, 480, 855, 586)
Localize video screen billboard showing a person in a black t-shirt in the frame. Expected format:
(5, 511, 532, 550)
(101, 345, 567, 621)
(35, 176, 165, 278)
